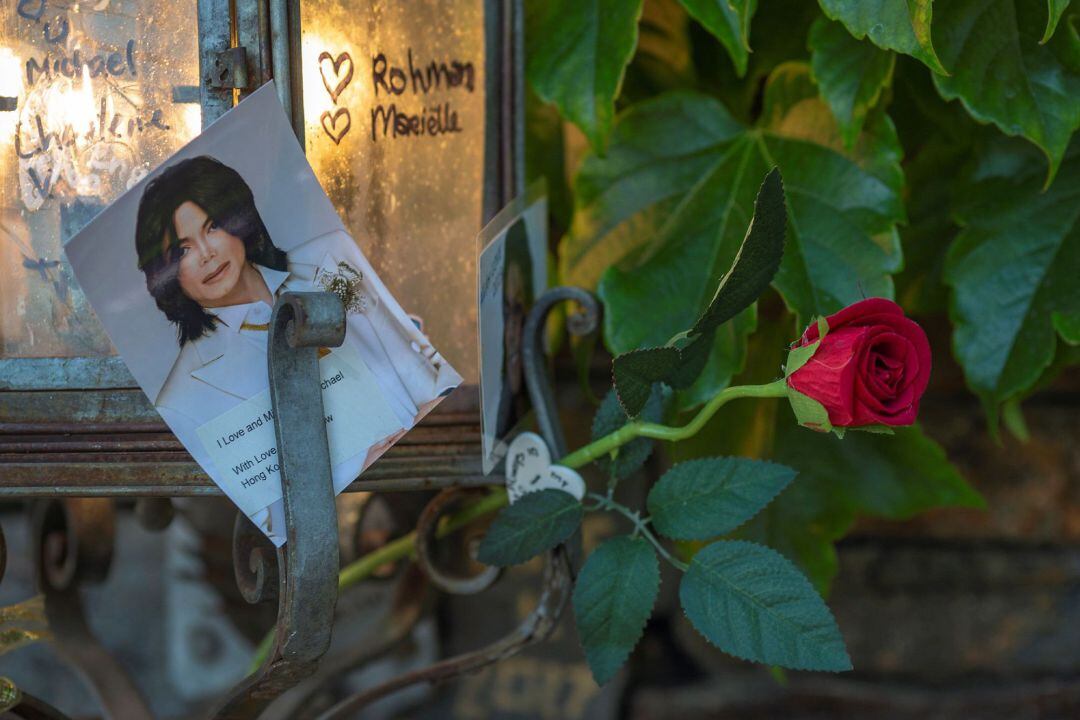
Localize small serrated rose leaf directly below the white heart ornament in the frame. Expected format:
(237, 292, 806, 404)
(476, 490, 584, 567)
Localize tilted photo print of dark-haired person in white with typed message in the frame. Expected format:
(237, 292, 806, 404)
(65, 84, 461, 546)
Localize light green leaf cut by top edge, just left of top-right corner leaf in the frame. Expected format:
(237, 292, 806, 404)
(820, 0, 951, 73)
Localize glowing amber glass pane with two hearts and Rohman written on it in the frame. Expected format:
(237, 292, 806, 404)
(300, 0, 484, 382)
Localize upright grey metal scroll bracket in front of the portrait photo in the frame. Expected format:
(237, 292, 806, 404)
(212, 293, 345, 720)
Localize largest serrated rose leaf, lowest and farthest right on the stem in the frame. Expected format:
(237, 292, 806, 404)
(679, 541, 851, 673)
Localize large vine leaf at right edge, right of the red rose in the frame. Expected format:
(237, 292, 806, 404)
(945, 139, 1080, 412)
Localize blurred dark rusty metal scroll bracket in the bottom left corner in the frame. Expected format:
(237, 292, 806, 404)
(33, 499, 153, 720)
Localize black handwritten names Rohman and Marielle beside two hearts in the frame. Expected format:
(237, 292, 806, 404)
(372, 47, 476, 141)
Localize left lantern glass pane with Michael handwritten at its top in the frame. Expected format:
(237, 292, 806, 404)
(0, 0, 200, 357)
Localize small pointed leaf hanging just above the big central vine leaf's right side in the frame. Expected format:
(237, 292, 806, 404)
(809, 17, 896, 148)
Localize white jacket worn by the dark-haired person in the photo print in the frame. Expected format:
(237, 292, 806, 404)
(154, 231, 461, 545)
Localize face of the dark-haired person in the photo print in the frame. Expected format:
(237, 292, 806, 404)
(173, 201, 246, 308)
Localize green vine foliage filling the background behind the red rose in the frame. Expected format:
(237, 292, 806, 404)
(526, 0, 1080, 590)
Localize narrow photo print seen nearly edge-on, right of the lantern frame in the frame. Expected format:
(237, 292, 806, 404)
(477, 181, 548, 475)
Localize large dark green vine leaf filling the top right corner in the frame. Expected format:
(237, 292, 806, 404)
(934, 0, 1080, 182)
